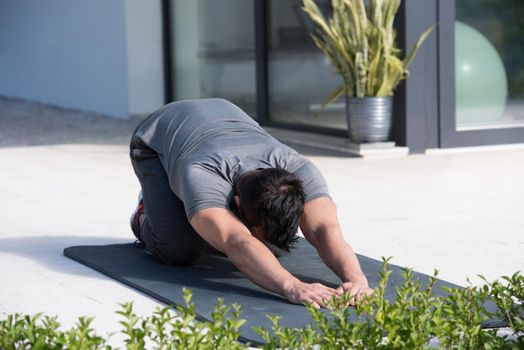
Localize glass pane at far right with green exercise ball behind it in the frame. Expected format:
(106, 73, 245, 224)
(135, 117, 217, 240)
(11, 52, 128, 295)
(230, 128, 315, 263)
(455, 0, 524, 130)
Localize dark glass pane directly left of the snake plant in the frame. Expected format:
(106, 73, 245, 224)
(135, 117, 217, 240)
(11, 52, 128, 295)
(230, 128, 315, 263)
(268, 0, 347, 129)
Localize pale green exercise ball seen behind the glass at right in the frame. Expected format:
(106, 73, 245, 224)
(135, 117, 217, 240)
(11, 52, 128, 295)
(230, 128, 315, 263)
(455, 22, 508, 125)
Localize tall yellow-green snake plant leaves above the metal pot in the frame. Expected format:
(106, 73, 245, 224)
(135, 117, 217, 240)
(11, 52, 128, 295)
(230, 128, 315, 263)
(302, 0, 433, 105)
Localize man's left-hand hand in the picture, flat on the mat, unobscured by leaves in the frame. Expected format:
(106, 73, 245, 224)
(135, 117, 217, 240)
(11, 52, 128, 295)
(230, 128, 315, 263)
(285, 279, 342, 309)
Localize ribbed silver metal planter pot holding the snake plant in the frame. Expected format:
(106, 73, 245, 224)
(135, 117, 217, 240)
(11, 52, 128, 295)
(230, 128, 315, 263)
(346, 96, 393, 143)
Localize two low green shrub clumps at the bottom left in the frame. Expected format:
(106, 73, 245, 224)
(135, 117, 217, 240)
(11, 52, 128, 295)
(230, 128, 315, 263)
(0, 289, 248, 350)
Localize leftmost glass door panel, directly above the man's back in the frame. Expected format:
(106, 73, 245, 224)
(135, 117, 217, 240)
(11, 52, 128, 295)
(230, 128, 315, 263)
(171, 0, 256, 117)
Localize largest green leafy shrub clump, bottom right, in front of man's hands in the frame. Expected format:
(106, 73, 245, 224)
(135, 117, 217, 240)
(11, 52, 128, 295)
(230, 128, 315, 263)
(257, 259, 524, 349)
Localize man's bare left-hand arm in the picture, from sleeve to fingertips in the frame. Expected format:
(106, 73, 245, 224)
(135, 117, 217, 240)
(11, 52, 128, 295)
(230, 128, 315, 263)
(191, 208, 340, 307)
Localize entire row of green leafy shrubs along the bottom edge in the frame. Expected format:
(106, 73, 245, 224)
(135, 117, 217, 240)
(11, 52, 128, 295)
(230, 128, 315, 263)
(0, 260, 524, 350)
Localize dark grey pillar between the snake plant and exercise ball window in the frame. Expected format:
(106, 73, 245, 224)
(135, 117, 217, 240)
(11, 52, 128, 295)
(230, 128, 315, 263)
(391, 0, 439, 153)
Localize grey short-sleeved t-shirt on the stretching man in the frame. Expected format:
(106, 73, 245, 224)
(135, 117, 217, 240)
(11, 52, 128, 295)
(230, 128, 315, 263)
(135, 99, 329, 220)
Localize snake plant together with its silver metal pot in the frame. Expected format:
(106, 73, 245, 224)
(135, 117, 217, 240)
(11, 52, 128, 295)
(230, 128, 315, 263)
(302, 0, 433, 142)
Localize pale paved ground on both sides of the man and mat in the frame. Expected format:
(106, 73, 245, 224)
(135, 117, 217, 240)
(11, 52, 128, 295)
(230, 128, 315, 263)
(0, 99, 524, 341)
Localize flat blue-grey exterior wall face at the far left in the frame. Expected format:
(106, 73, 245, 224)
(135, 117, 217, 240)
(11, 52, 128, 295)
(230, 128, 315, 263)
(0, 0, 129, 117)
